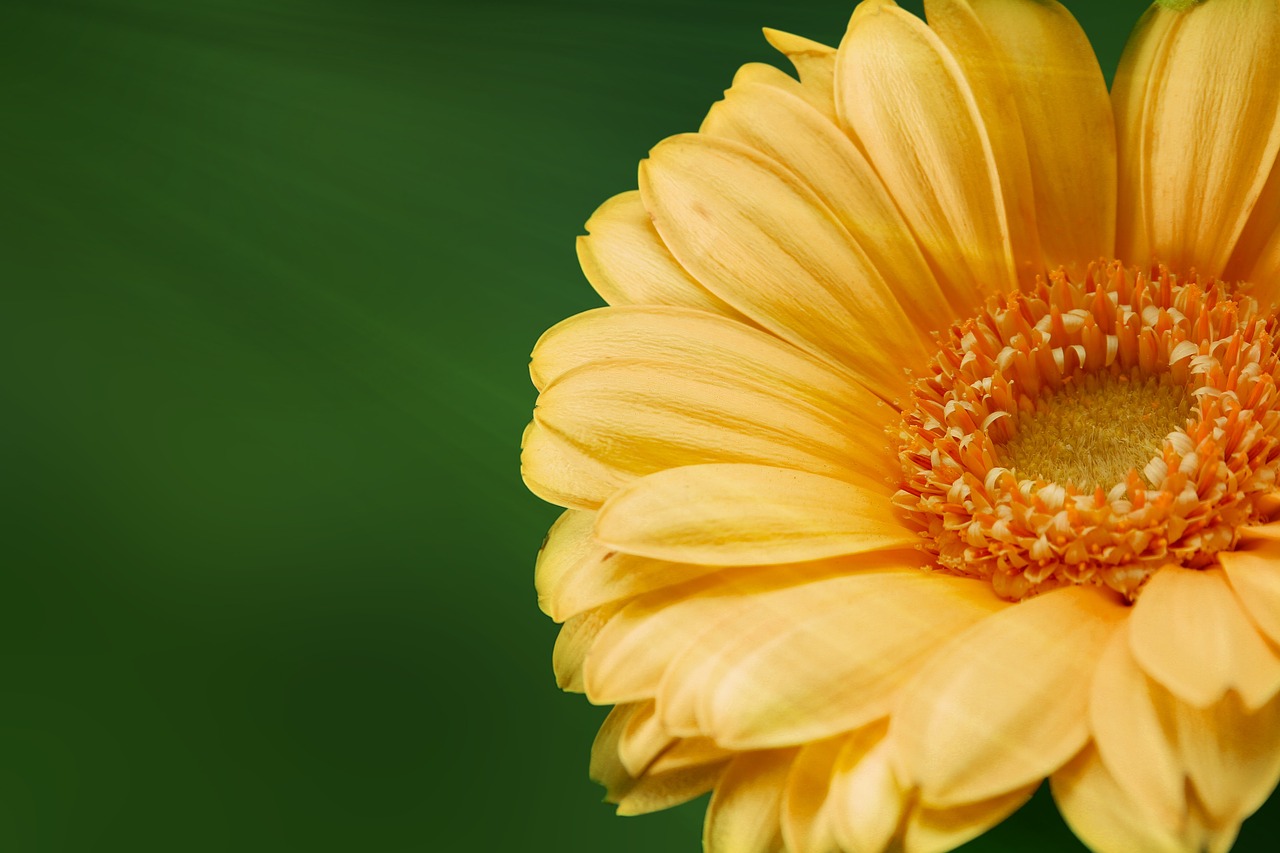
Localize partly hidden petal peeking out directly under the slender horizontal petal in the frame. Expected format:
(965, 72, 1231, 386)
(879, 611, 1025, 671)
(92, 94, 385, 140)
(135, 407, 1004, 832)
(534, 510, 722, 622)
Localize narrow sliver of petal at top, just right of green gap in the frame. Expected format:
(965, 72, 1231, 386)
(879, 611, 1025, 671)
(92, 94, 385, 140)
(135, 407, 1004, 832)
(1111, 4, 1180, 266)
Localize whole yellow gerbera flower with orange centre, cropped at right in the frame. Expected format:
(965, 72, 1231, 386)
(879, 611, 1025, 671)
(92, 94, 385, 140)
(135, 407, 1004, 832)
(522, 0, 1280, 853)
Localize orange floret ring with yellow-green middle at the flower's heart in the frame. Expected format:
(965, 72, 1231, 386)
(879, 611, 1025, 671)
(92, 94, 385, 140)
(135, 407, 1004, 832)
(895, 263, 1280, 599)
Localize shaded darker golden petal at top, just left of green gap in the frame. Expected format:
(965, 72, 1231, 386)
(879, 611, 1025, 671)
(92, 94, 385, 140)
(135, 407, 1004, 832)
(962, 0, 1116, 274)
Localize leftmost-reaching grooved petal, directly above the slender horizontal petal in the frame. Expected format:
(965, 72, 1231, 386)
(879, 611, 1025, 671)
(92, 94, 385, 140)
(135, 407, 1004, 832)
(521, 348, 893, 508)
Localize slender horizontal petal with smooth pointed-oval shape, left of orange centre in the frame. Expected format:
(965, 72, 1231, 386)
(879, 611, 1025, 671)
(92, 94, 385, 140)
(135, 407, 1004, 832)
(595, 465, 919, 566)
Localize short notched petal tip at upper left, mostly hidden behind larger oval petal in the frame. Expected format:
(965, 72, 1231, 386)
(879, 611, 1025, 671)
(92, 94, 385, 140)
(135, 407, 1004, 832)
(577, 190, 741, 318)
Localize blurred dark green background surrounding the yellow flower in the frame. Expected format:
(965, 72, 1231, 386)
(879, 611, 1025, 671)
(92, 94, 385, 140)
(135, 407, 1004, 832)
(0, 0, 1280, 853)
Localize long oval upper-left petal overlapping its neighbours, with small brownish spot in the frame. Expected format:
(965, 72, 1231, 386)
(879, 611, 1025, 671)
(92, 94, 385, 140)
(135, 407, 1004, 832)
(640, 134, 932, 400)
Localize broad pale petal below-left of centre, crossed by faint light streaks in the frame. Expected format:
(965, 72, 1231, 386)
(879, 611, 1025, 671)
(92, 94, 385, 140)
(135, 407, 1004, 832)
(696, 570, 1007, 749)
